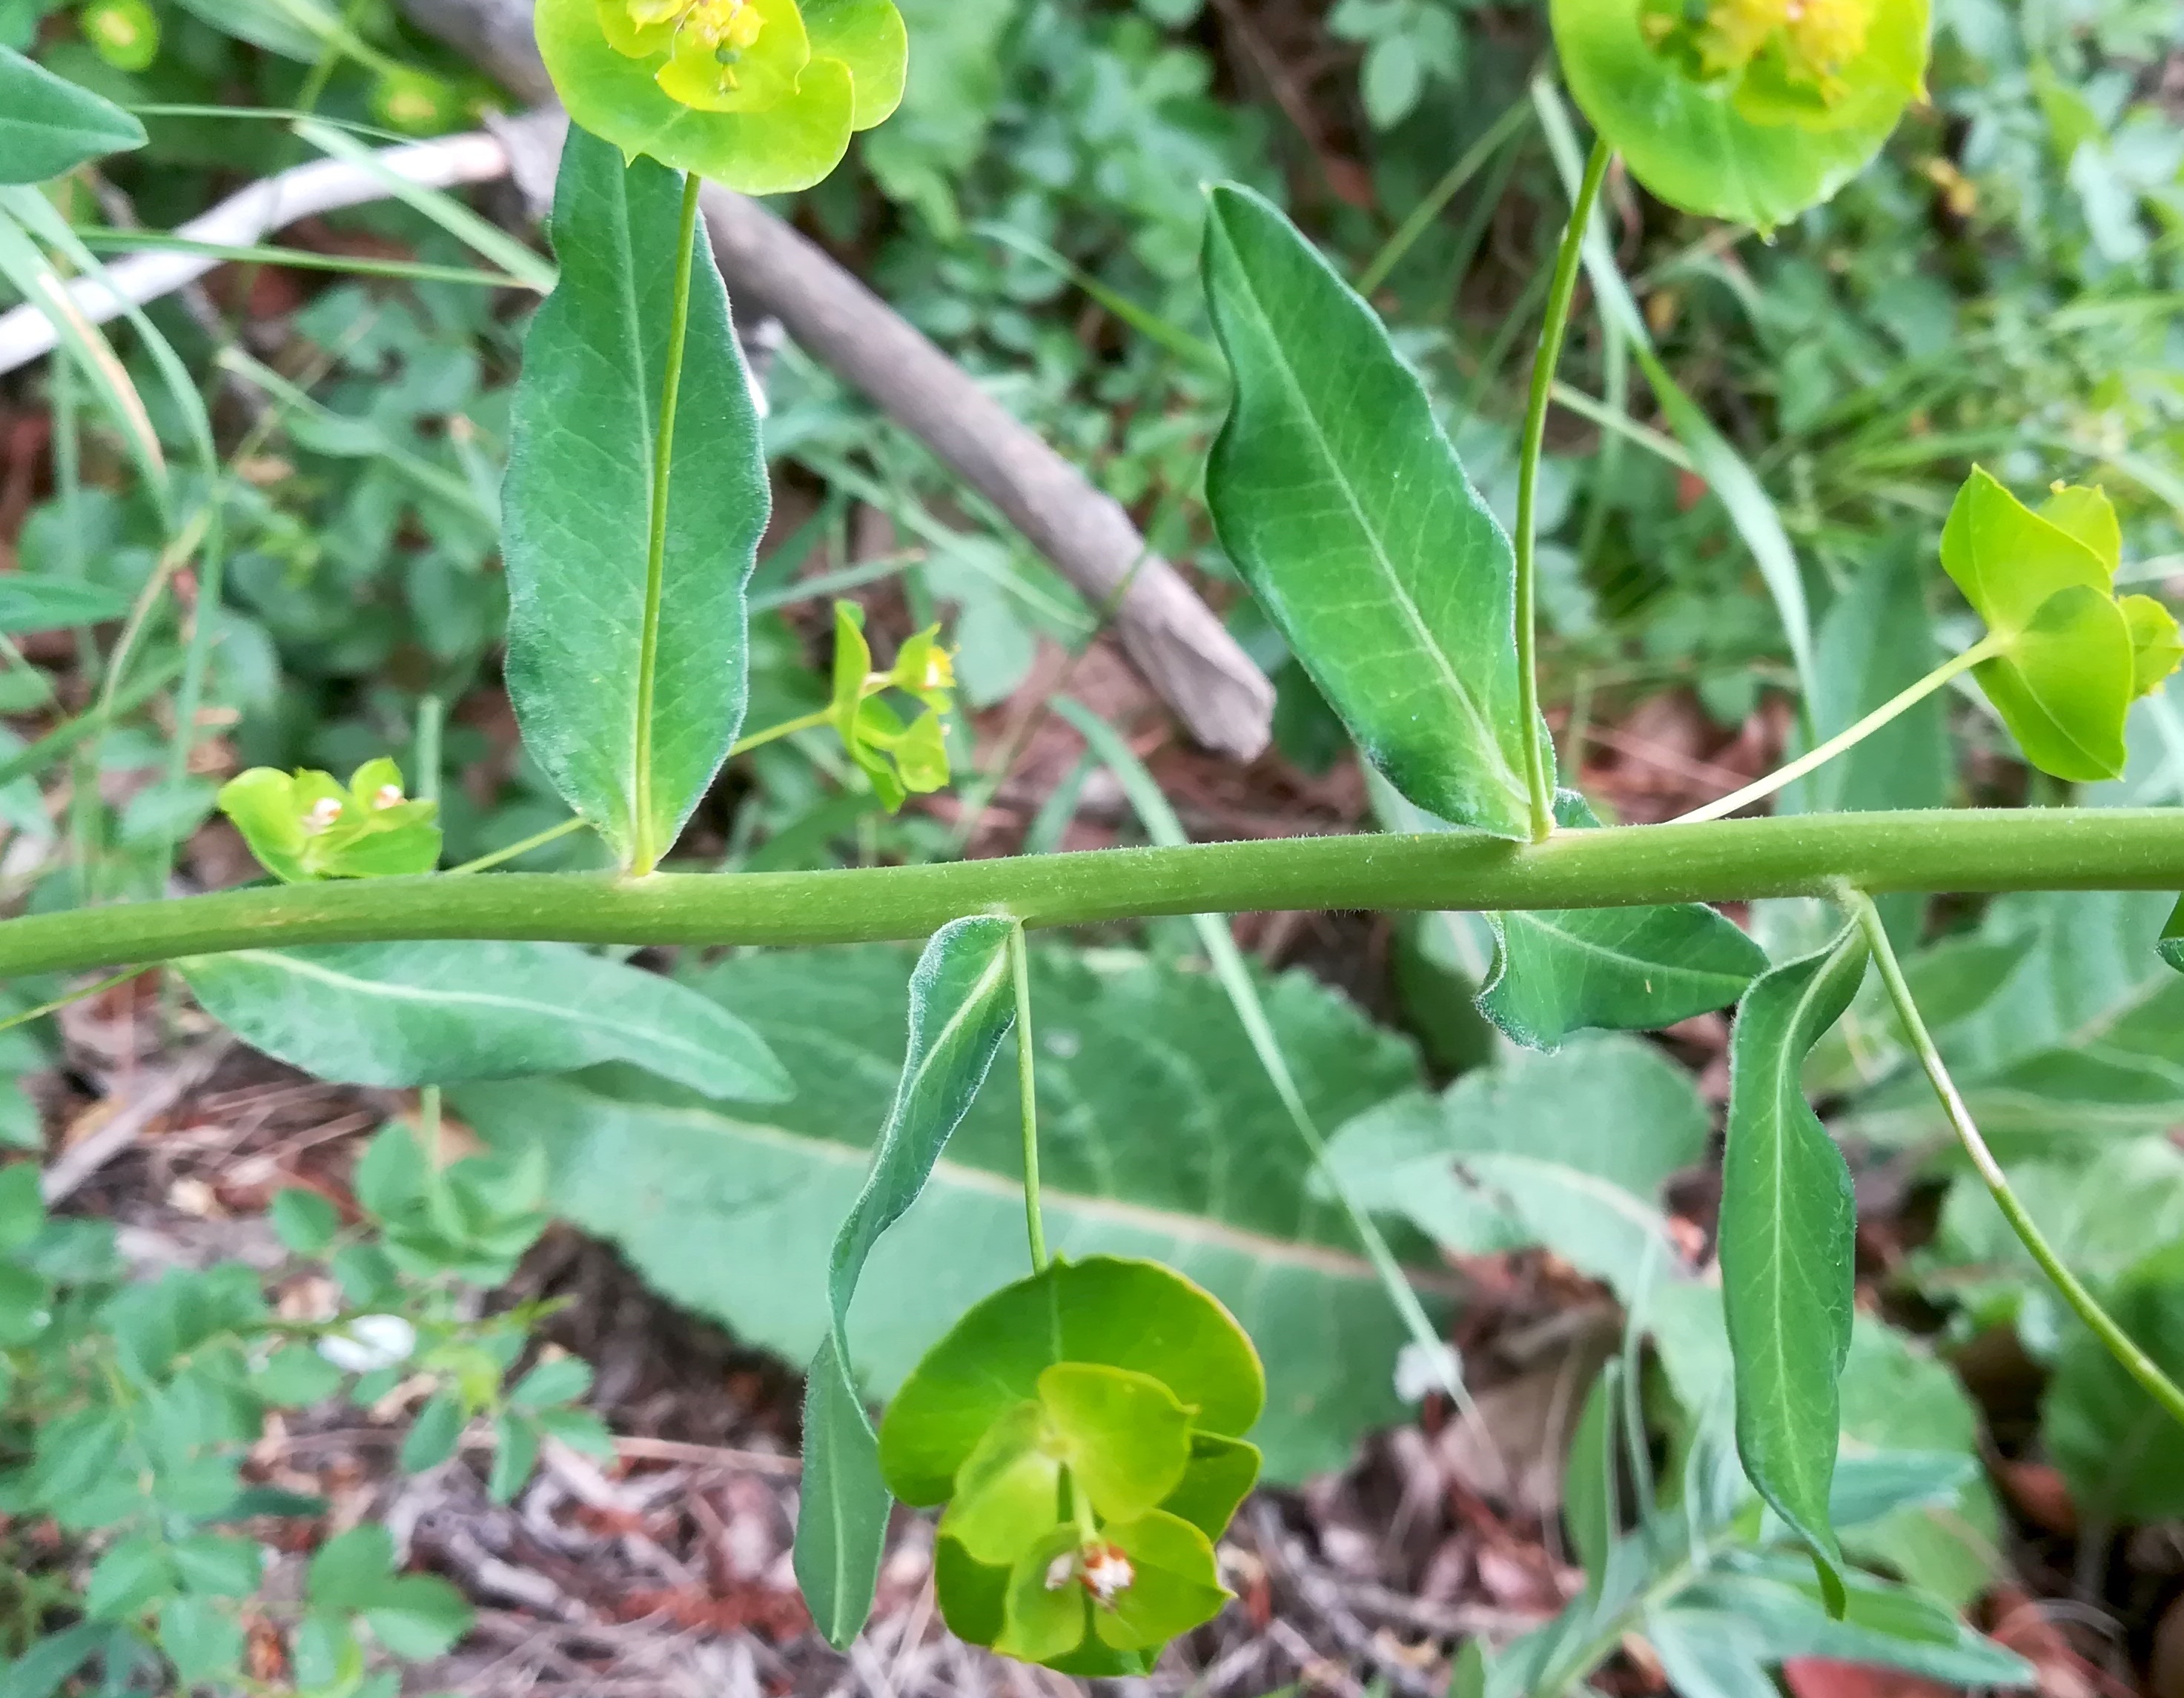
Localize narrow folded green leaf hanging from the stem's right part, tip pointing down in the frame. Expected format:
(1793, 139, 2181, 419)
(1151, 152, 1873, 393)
(1721, 929, 1865, 1606)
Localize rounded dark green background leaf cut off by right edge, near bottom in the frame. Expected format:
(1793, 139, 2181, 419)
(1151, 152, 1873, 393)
(2040, 1244, 2184, 1525)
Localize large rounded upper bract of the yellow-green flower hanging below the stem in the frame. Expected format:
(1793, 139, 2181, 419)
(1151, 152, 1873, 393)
(880, 1255, 1267, 1504)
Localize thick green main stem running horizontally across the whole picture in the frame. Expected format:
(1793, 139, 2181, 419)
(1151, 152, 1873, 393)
(13, 808, 2184, 978)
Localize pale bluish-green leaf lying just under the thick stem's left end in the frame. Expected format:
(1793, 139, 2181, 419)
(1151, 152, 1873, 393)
(175, 941, 790, 1102)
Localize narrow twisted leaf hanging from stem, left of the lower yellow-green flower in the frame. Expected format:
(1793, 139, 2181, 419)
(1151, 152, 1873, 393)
(797, 917, 1016, 1645)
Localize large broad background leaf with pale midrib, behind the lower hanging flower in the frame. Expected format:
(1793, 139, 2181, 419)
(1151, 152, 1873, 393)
(452, 945, 1417, 1480)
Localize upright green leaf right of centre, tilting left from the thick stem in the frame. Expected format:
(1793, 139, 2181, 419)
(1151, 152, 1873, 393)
(1205, 185, 1553, 838)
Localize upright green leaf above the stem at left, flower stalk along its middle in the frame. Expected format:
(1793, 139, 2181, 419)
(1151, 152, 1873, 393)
(505, 129, 769, 864)
